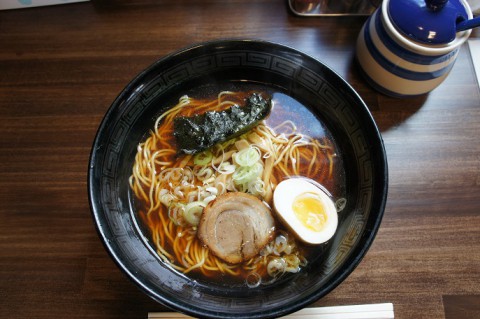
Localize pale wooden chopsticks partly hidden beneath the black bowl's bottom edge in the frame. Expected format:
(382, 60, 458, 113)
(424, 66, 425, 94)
(148, 303, 394, 319)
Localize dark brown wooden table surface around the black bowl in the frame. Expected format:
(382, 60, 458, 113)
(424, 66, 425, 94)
(0, 0, 480, 319)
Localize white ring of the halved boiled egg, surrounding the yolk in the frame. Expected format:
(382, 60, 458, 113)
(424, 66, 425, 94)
(273, 178, 338, 244)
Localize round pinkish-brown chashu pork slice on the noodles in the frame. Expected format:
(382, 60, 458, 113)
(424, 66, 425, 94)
(197, 192, 275, 264)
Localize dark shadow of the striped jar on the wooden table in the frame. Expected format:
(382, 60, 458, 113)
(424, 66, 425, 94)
(346, 58, 429, 132)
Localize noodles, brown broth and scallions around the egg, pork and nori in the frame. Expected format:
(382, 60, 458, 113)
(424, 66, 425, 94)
(129, 91, 343, 287)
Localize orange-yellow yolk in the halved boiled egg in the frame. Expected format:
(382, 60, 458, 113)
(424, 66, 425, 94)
(292, 193, 327, 232)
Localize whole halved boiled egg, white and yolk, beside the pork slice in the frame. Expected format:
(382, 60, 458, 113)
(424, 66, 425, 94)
(273, 178, 338, 244)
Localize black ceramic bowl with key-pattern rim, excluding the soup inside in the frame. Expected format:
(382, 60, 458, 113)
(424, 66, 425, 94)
(88, 40, 388, 318)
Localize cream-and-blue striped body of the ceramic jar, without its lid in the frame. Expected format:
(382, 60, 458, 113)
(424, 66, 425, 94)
(356, 0, 472, 97)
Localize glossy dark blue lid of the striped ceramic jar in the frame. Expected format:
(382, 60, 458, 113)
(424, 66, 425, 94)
(388, 0, 468, 44)
